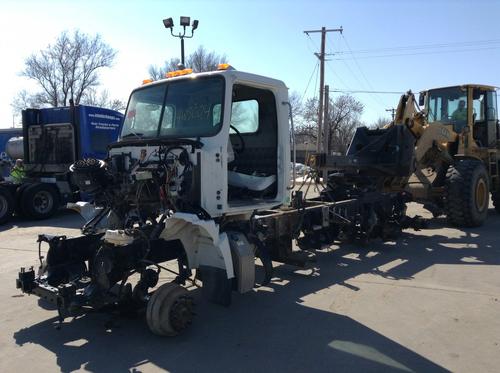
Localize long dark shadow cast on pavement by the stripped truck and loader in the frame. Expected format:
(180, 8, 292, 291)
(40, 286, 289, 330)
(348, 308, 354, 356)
(13, 208, 500, 372)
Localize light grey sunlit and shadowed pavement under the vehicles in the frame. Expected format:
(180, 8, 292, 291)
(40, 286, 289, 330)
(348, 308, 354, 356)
(0, 205, 500, 372)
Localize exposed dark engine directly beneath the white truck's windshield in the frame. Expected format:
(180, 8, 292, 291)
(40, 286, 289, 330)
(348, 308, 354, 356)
(70, 143, 203, 232)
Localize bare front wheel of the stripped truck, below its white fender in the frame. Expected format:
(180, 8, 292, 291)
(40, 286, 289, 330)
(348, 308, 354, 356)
(146, 282, 194, 337)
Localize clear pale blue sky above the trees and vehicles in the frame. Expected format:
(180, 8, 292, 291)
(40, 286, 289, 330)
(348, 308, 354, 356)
(0, 0, 500, 127)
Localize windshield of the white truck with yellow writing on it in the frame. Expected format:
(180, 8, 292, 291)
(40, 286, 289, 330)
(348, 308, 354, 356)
(121, 76, 224, 138)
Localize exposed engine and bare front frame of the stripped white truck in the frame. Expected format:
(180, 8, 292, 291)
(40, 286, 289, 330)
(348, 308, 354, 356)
(18, 140, 213, 335)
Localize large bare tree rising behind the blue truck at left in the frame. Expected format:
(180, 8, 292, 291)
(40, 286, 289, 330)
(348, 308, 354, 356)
(21, 30, 116, 107)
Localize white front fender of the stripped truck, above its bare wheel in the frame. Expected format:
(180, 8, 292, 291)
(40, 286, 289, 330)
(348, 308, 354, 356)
(160, 212, 234, 279)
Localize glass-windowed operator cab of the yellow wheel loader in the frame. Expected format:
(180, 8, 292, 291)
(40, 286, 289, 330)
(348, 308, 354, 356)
(420, 84, 499, 148)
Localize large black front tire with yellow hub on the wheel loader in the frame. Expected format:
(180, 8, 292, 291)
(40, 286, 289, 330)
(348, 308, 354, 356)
(444, 159, 490, 227)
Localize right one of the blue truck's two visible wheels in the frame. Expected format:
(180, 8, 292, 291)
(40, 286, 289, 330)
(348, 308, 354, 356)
(21, 183, 60, 220)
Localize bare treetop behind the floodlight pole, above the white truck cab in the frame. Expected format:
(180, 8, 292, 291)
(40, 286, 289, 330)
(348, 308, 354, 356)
(148, 46, 227, 80)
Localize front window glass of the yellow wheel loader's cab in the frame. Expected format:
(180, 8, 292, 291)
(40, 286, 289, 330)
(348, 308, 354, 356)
(427, 87, 467, 127)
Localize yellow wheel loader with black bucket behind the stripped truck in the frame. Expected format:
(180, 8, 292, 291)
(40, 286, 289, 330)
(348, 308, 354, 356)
(311, 84, 500, 227)
